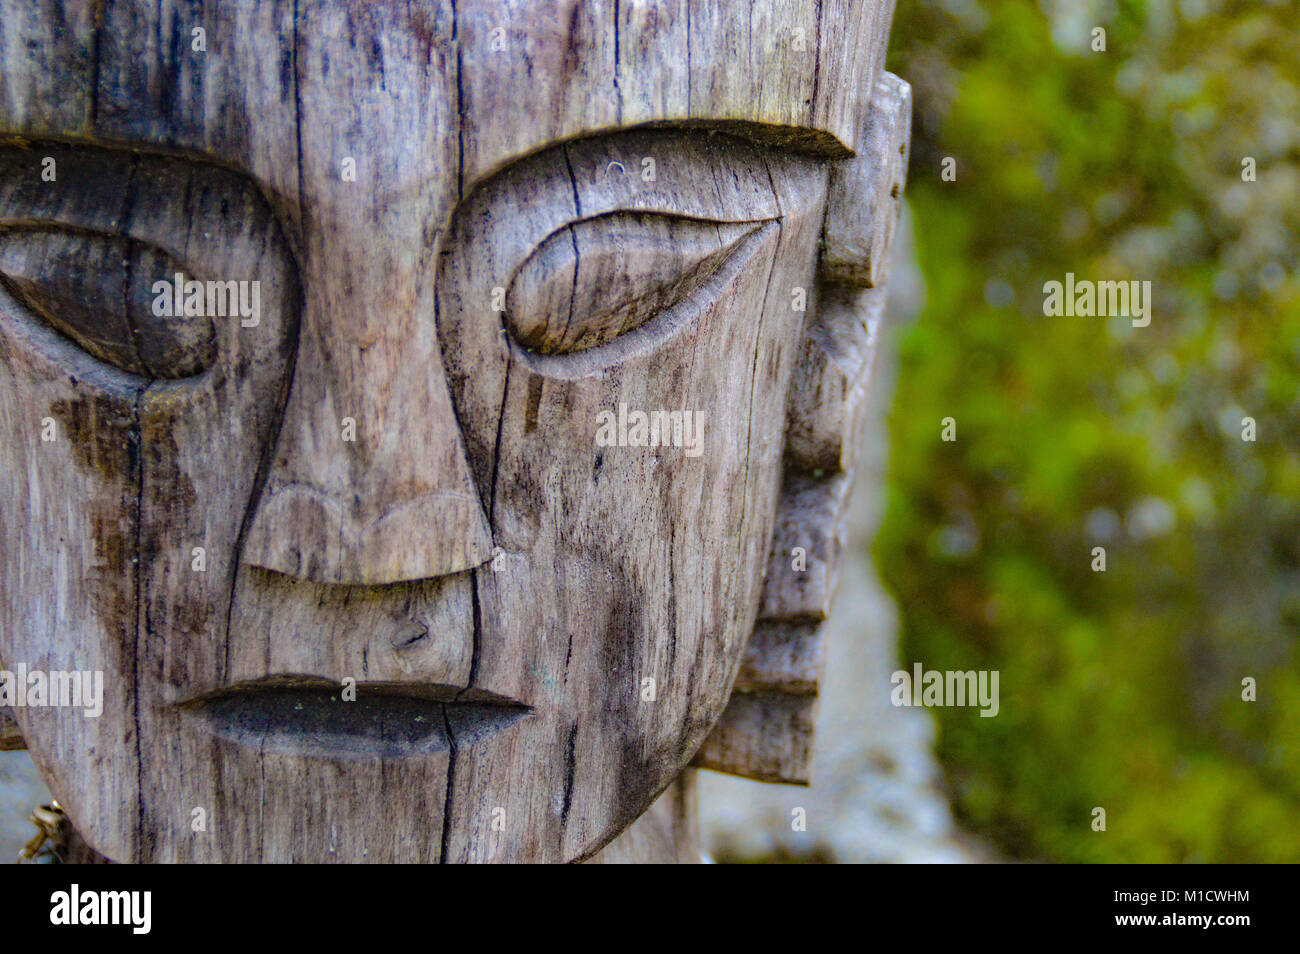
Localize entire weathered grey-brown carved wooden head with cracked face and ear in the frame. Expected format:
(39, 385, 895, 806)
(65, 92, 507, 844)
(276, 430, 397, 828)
(0, 0, 910, 863)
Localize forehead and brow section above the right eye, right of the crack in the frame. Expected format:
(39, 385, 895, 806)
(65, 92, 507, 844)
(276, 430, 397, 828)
(455, 0, 893, 185)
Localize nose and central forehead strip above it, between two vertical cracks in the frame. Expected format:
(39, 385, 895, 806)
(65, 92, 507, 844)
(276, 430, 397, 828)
(236, 4, 491, 585)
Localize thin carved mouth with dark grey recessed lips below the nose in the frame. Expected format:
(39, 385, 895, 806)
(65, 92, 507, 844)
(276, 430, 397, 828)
(179, 676, 533, 759)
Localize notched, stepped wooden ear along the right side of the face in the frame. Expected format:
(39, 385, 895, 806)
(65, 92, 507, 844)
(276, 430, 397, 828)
(693, 73, 911, 785)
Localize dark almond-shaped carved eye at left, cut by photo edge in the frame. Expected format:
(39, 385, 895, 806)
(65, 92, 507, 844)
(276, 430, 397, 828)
(0, 230, 217, 378)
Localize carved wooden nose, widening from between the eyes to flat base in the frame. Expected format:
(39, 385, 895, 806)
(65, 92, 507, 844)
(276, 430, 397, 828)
(243, 207, 491, 585)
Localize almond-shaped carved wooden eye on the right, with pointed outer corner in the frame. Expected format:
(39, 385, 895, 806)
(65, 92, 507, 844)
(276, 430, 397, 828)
(506, 212, 762, 355)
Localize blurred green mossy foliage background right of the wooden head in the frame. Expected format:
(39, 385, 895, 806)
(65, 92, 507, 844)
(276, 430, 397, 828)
(876, 0, 1300, 862)
